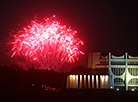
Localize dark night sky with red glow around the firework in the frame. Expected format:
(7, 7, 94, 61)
(0, 0, 138, 71)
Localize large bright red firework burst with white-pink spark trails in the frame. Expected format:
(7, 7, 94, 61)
(11, 15, 84, 71)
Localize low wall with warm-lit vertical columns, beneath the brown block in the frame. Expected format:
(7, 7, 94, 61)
(66, 74, 111, 89)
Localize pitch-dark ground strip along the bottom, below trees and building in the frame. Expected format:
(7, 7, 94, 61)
(0, 89, 138, 102)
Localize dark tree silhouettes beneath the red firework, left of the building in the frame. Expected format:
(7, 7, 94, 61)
(0, 65, 67, 90)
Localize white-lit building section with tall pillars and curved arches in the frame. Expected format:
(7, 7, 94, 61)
(108, 52, 138, 90)
